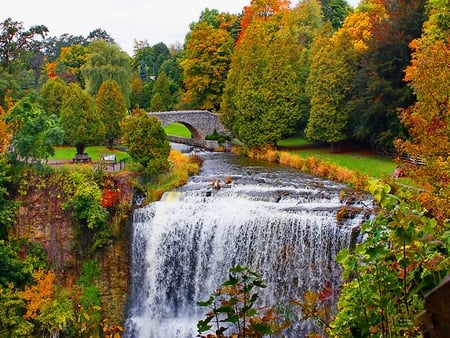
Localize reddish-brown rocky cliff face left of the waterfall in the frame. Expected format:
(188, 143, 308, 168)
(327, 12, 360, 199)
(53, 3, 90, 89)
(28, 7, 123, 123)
(9, 175, 132, 323)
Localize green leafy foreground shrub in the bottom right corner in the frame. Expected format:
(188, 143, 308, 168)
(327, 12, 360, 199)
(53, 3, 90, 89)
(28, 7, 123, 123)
(329, 181, 450, 337)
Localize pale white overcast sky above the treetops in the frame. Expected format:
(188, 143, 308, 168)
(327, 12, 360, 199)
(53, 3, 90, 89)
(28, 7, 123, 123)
(0, 0, 359, 56)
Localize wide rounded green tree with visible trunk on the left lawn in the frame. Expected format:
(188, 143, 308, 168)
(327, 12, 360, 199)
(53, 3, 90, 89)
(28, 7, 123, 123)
(61, 83, 105, 154)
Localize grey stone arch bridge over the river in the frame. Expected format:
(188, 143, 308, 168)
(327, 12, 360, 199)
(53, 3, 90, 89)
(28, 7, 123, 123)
(148, 110, 230, 147)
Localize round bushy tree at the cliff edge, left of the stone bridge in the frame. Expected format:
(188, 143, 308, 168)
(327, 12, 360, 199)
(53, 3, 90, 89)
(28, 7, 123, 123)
(120, 110, 170, 177)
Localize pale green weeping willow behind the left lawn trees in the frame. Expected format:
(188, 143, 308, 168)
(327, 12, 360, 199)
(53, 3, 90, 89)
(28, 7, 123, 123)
(81, 40, 133, 107)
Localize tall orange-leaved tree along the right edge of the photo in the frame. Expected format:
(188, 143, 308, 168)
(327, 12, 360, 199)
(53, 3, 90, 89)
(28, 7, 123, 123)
(396, 1, 450, 220)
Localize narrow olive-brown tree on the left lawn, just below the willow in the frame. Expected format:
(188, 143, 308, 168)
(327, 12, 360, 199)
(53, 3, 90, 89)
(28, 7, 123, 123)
(96, 80, 127, 149)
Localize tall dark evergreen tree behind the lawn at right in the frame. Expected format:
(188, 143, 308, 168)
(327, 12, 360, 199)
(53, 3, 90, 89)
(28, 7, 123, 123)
(348, 0, 425, 148)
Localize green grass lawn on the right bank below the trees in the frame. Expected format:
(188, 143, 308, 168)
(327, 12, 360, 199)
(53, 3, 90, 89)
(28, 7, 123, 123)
(277, 137, 397, 178)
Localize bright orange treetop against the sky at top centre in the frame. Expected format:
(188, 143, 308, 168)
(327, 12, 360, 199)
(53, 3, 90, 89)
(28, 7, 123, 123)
(237, 0, 290, 44)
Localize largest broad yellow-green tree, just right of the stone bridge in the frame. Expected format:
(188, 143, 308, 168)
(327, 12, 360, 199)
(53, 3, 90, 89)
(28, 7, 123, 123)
(221, 1, 321, 146)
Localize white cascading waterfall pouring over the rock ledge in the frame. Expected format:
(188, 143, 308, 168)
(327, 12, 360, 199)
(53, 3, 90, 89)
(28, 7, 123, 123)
(125, 154, 370, 338)
